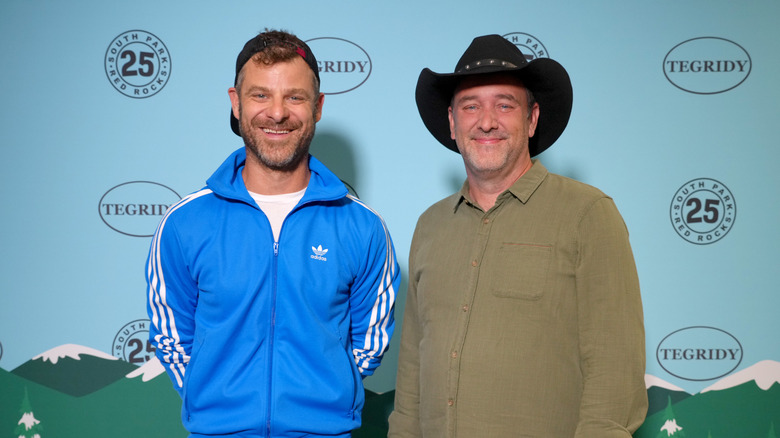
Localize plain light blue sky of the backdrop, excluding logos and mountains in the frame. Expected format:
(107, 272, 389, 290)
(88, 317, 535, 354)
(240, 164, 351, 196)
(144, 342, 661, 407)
(0, 0, 780, 404)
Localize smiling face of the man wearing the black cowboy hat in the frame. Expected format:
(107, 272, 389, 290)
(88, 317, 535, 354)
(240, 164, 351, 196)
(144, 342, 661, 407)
(449, 74, 539, 181)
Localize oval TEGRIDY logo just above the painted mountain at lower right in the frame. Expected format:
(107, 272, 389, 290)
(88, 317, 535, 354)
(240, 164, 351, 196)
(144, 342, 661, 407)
(655, 326, 743, 382)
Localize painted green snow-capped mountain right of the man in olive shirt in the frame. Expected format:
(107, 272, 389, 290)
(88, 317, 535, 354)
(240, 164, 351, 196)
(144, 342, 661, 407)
(634, 360, 780, 438)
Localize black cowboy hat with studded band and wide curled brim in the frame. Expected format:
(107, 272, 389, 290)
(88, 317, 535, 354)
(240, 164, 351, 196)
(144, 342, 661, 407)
(415, 35, 572, 157)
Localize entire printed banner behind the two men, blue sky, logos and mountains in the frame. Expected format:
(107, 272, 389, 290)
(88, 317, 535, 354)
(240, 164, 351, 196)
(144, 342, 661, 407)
(0, 0, 780, 438)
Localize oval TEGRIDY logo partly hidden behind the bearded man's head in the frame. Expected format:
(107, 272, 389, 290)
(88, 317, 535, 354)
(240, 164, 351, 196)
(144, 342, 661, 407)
(306, 37, 372, 94)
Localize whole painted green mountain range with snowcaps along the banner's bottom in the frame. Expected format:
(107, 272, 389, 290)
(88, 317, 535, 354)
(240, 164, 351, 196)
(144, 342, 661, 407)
(0, 345, 780, 438)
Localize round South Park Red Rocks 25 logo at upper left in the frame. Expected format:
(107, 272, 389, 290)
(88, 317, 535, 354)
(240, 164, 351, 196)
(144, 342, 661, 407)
(105, 30, 171, 99)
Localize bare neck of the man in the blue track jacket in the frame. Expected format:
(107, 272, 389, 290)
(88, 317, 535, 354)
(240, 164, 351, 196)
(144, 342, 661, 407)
(241, 156, 311, 195)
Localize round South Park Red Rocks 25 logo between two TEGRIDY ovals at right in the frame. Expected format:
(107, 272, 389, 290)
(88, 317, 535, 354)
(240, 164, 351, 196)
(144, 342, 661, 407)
(670, 178, 737, 245)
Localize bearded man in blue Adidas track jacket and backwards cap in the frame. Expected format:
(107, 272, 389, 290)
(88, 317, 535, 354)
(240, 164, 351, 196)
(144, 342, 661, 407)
(146, 31, 400, 438)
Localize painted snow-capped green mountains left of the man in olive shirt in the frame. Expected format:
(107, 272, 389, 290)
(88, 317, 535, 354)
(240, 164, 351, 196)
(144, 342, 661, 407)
(0, 344, 393, 438)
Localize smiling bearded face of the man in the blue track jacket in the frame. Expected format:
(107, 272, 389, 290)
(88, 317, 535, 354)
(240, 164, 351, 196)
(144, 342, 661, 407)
(228, 57, 324, 175)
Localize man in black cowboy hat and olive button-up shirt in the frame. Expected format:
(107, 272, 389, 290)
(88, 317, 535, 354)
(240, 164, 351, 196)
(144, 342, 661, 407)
(389, 35, 647, 438)
